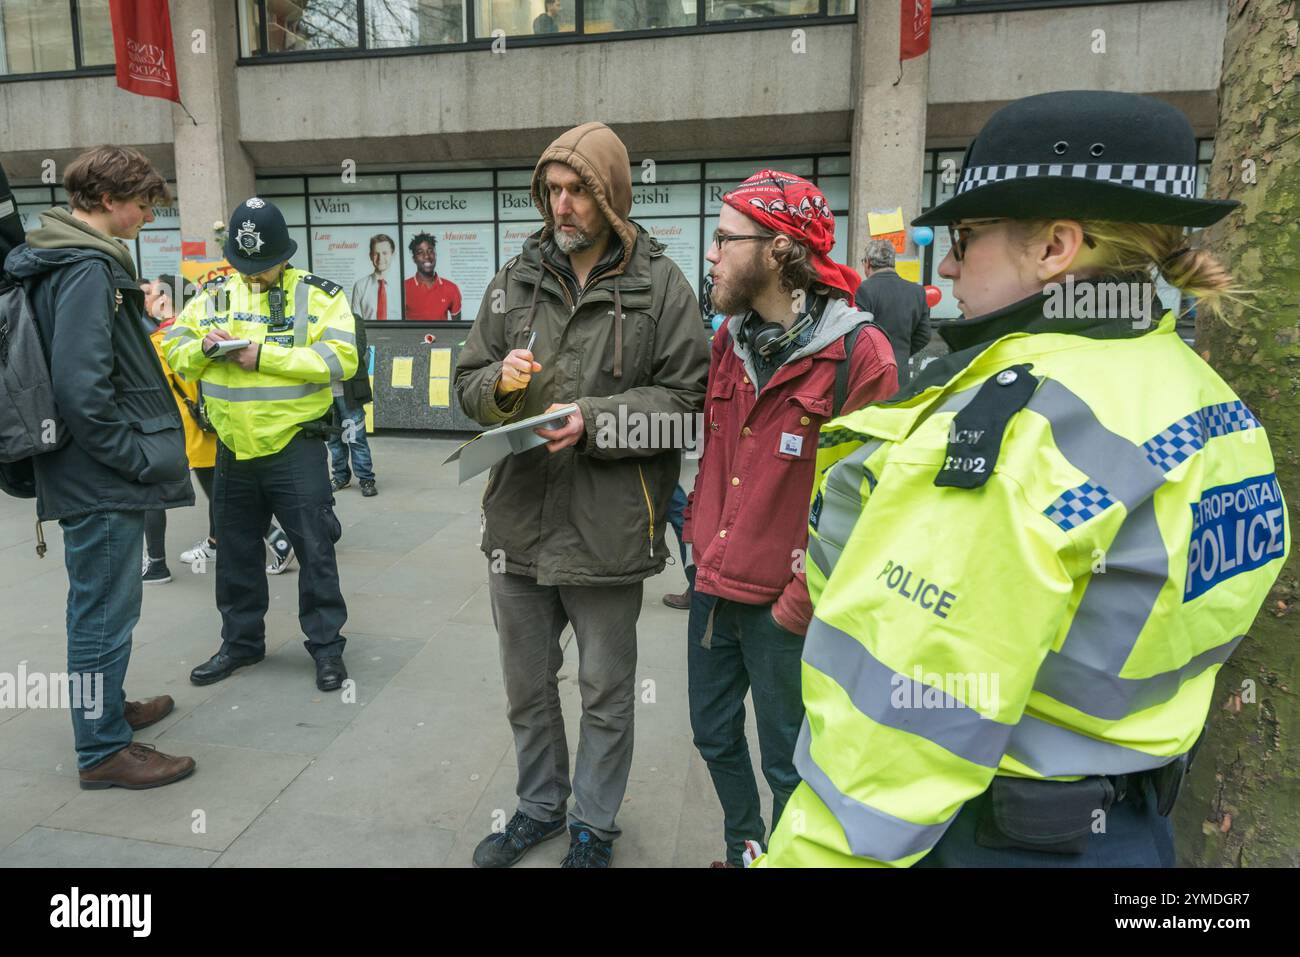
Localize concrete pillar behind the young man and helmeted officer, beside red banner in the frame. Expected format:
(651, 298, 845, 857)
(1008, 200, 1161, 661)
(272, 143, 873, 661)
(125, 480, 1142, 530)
(172, 0, 254, 256)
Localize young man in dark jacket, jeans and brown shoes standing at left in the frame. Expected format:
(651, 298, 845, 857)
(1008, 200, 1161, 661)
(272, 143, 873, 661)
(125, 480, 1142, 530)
(5, 146, 194, 789)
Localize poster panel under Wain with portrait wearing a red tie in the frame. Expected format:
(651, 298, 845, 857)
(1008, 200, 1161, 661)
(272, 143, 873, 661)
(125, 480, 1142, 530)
(311, 224, 402, 321)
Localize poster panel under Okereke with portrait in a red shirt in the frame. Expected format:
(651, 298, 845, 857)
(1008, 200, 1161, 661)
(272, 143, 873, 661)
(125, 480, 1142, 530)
(402, 222, 497, 320)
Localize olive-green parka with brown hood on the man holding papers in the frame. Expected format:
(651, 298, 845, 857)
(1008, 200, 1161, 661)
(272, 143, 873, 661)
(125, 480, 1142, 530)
(455, 124, 709, 585)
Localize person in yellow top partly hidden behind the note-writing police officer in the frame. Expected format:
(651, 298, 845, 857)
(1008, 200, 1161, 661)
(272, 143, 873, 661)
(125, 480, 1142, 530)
(140, 274, 217, 585)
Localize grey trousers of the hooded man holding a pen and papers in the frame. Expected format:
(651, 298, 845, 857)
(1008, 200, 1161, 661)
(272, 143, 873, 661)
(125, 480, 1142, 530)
(488, 572, 642, 841)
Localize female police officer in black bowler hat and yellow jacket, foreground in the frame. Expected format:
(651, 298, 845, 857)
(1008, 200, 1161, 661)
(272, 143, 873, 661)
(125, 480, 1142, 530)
(761, 92, 1290, 866)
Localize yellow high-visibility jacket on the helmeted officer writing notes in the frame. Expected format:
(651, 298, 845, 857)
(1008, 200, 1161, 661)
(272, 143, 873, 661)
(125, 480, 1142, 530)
(163, 269, 358, 459)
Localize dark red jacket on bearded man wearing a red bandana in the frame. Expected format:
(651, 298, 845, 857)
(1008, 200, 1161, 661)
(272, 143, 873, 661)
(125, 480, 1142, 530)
(684, 302, 898, 635)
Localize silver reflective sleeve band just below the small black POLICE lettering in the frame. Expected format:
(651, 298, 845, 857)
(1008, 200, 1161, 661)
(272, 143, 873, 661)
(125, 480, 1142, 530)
(803, 616, 1013, 767)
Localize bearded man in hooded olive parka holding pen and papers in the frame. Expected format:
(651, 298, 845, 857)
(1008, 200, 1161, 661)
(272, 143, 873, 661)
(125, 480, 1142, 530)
(456, 122, 709, 867)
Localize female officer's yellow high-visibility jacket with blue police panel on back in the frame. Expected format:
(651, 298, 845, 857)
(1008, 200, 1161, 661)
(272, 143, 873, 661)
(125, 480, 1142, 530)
(759, 296, 1290, 866)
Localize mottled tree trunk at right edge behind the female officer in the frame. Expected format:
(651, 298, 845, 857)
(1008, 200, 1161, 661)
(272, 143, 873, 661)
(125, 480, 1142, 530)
(1174, 0, 1300, 867)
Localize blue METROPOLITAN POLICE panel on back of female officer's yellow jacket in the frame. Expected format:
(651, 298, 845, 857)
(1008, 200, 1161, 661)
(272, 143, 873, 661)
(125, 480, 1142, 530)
(1183, 473, 1286, 602)
